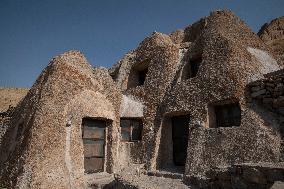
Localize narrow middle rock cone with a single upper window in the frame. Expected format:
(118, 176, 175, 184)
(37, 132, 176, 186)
(110, 32, 179, 170)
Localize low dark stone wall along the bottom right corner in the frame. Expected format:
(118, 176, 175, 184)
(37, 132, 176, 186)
(203, 163, 284, 189)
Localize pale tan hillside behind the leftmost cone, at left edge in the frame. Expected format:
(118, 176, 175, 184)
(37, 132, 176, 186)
(0, 88, 29, 112)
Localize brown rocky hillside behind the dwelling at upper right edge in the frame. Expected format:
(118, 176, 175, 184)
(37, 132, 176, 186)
(258, 16, 284, 66)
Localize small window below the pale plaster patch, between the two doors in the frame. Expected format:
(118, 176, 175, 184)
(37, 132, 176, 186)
(120, 118, 143, 142)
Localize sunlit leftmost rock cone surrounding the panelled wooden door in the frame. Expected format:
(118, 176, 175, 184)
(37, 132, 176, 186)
(0, 51, 121, 188)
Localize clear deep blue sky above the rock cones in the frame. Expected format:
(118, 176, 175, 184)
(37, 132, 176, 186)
(0, 0, 284, 87)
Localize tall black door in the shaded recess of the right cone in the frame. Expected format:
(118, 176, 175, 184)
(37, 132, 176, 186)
(172, 115, 190, 166)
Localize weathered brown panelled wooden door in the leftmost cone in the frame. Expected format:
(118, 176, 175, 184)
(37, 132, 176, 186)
(83, 119, 106, 173)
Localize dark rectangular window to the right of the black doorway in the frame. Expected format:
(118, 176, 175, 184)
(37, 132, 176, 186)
(209, 102, 241, 127)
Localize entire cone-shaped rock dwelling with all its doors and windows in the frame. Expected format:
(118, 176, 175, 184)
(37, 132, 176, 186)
(0, 11, 284, 188)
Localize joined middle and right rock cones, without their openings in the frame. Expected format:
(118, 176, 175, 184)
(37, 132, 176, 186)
(111, 11, 281, 176)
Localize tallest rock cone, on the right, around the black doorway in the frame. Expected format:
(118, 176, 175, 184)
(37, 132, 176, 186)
(153, 11, 280, 175)
